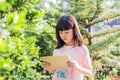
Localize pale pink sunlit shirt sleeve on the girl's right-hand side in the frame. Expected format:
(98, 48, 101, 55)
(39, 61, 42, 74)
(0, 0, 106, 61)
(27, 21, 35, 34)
(82, 45, 92, 71)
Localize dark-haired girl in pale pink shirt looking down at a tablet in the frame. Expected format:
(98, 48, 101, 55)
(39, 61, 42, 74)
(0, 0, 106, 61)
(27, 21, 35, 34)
(42, 15, 92, 80)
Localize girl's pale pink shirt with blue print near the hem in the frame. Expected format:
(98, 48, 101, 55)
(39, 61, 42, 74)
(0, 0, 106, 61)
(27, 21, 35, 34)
(52, 45, 92, 80)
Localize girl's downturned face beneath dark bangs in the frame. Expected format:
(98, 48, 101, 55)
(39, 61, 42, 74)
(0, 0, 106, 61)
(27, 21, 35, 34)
(59, 29, 74, 45)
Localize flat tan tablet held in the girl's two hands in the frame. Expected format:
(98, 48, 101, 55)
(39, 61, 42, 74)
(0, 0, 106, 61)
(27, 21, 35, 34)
(40, 55, 69, 71)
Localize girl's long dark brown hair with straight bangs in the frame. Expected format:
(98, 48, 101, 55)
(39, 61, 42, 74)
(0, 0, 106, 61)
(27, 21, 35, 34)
(56, 15, 83, 49)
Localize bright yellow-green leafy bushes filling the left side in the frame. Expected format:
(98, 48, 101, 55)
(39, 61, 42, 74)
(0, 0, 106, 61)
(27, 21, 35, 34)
(0, 0, 48, 80)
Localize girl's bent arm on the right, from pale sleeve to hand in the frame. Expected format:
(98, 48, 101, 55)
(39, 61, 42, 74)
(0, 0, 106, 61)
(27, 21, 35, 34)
(68, 46, 92, 77)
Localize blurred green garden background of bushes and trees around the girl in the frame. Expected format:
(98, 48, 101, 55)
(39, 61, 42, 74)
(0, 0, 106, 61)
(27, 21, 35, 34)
(0, 0, 120, 80)
